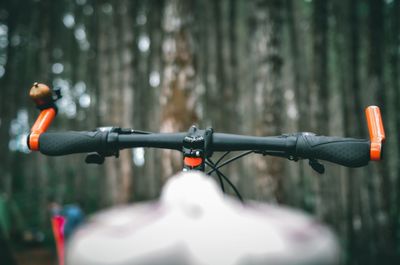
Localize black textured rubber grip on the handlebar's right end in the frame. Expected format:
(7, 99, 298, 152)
(296, 134, 370, 167)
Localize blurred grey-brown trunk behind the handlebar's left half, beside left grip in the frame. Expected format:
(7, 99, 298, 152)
(98, 1, 133, 204)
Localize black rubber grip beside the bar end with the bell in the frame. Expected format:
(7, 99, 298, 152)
(39, 131, 108, 156)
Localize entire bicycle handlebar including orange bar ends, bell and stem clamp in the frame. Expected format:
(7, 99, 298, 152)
(28, 83, 385, 167)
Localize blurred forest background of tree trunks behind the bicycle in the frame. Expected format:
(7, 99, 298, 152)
(0, 0, 400, 265)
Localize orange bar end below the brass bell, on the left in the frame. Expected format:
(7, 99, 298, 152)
(29, 108, 57, 148)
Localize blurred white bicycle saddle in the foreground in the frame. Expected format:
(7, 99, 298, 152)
(67, 172, 339, 265)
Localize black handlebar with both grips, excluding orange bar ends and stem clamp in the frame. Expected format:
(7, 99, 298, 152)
(39, 131, 370, 167)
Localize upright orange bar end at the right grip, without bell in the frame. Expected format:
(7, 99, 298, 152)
(365, 106, 386, 161)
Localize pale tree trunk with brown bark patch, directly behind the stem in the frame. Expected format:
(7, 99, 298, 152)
(160, 0, 197, 179)
